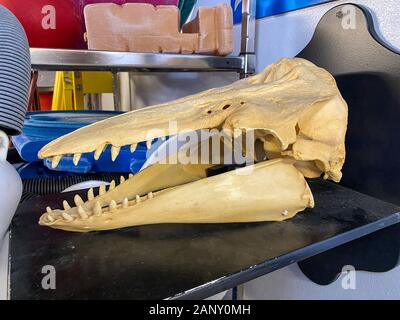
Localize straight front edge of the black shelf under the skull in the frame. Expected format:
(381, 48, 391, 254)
(166, 212, 400, 300)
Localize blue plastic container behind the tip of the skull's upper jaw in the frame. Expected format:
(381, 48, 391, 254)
(12, 111, 153, 173)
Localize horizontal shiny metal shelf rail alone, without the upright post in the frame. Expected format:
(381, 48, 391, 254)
(31, 48, 245, 72)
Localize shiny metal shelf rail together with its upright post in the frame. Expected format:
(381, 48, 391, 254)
(31, 0, 256, 77)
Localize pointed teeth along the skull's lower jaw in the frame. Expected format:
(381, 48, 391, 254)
(46, 192, 154, 223)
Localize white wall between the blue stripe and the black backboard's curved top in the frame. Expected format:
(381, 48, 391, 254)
(250, 0, 400, 70)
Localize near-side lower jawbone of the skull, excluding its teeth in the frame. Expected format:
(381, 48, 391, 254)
(40, 159, 314, 232)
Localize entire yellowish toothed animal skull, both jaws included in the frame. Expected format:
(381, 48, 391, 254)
(39, 58, 347, 232)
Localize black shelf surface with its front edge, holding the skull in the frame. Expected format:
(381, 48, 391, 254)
(10, 179, 400, 299)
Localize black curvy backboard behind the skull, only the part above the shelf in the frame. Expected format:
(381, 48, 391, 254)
(298, 4, 400, 204)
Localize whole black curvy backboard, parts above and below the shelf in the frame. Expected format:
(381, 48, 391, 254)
(298, 4, 400, 285)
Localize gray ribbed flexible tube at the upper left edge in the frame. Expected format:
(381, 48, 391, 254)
(0, 5, 31, 135)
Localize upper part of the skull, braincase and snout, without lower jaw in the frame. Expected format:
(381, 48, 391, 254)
(39, 58, 347, 181)
